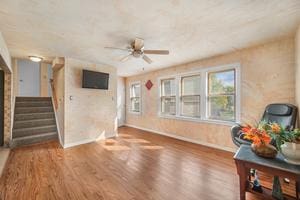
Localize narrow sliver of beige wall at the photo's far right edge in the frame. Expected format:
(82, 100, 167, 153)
(295, 26, 300, 127)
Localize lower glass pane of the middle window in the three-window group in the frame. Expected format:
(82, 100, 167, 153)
(181, 95, 200, 118)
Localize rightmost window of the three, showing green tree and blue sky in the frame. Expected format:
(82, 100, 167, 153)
(207, 70, 235, 121)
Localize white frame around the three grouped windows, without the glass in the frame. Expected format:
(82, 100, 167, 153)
(157, 63, 241, 126)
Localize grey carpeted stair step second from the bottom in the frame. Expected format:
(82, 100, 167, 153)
(12, 125, 57, 138)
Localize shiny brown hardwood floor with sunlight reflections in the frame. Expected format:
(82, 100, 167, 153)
(0, 127, 294, 200)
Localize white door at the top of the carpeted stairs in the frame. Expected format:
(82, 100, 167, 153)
(18, 60, 40, 97)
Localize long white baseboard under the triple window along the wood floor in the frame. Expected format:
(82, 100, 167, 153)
(125, 124, 236, 153)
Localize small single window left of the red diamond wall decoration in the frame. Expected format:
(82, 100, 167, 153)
(130, 83, 141, 113)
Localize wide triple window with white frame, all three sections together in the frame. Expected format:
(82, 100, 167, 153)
(159, 64, 240, 125)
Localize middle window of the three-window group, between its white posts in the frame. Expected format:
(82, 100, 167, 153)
(180, 75, 201, 118)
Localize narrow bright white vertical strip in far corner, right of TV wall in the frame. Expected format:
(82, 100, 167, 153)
(117, 76, 126, 127)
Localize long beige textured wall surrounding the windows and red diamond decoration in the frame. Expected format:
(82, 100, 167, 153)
(126, 38, 295, 151)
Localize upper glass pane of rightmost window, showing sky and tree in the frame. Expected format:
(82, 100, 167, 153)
(208, 70, 235, 94)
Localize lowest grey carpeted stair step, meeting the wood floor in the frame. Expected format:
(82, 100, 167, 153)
(10, 132, 58, 148)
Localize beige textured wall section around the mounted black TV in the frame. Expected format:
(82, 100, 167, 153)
(64, 58, 117, 147)
